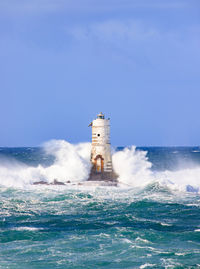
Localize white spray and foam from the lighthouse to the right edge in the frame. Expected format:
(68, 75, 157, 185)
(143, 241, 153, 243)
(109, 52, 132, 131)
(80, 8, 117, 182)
(113, 146, 200, 193)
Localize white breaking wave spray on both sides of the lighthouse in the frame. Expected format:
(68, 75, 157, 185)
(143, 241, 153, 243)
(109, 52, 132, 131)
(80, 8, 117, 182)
(0, 140, 200, 193)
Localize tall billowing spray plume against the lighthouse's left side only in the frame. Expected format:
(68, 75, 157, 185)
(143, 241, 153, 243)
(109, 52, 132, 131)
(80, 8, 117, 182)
(43, 140, 91, 182)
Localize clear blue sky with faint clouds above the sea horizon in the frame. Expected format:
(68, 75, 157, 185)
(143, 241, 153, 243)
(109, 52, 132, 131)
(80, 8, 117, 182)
(0, 0, 200, 147)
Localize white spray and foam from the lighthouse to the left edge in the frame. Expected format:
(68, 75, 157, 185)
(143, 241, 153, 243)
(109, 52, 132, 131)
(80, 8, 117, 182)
(0, 140, 91, 187)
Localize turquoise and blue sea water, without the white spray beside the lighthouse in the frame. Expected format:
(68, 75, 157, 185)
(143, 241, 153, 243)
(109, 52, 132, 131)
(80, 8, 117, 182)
(0, 148, 200, 269)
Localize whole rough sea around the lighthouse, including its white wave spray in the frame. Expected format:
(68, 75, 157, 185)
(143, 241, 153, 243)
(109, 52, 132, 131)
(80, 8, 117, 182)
(0, 140, 200, 269)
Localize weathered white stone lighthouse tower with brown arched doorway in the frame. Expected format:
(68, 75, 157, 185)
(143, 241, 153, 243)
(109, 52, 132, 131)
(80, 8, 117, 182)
(88, 112, 117, 182)
